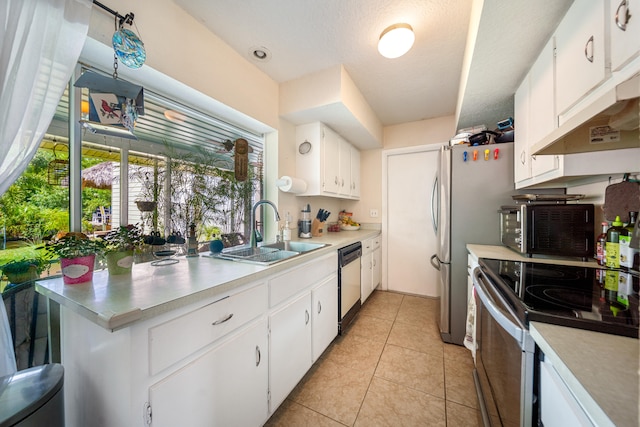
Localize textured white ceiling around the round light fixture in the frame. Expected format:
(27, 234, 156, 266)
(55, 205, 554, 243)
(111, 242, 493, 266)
(174, 0, 573, 134)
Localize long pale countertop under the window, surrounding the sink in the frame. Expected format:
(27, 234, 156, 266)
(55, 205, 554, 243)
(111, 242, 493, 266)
(36, 228, 380, 330)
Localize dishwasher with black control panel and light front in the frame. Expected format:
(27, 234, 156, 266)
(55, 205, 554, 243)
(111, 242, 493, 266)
(338, 242, 362, 334)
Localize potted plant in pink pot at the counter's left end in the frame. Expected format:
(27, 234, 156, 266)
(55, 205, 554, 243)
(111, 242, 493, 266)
(46, 232, 104, 285)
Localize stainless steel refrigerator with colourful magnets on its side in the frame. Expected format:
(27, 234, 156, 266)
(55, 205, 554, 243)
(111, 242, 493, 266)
(431, 142, 516, 345)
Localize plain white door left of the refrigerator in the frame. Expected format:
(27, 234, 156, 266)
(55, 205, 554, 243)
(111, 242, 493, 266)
(382, 144, 441, 297)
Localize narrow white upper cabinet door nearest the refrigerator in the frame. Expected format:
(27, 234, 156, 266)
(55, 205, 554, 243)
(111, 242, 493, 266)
(513, 74, 531, 183)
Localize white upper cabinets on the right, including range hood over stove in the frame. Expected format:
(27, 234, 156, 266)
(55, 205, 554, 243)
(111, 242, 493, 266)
(514, 0, 640, 188)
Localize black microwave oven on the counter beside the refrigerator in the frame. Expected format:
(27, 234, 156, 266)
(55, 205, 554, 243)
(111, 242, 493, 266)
(500, 204, 595, 261)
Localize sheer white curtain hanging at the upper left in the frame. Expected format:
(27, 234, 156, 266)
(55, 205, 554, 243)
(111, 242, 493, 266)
(0, 0, 93, 195)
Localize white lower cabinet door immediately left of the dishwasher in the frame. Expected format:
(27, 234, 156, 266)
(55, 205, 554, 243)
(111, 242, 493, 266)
(311, 276, 338, 362)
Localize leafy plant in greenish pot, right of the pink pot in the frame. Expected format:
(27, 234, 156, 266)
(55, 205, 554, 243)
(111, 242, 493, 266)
(103, 224, 144, 274)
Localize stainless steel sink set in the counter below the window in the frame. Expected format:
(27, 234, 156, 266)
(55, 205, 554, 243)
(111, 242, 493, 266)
(212, 242, 329, 265)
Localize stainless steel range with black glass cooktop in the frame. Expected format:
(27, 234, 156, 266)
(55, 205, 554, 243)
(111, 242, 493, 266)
(473, 259, 639, 426)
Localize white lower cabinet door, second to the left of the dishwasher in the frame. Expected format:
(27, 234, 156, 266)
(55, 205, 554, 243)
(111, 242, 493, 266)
(269, 292, 312, 411)
